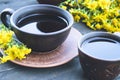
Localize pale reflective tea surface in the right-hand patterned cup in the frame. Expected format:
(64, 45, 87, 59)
(81, 37, 120, 60)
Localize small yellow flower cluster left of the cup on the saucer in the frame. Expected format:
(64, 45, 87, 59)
(0, 24, 31, 63)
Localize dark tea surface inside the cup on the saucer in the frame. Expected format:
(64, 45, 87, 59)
(17, 14, 68, 34)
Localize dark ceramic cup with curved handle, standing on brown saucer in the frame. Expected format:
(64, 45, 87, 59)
(1, 4, 74, 52)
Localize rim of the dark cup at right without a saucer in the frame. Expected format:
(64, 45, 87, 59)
(78, 31, 120, 62)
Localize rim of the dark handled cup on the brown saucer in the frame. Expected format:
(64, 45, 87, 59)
(10, 4, 74, 36)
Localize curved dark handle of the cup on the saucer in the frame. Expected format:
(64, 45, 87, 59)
(0, 8, 14, 29)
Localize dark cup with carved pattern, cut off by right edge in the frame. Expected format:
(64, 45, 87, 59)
(78, 32, 120, 80)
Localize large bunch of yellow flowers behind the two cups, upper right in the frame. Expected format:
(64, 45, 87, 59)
(59, 0, 120, 32)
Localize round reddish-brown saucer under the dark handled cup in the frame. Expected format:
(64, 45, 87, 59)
(11, 28, 82, 68)
